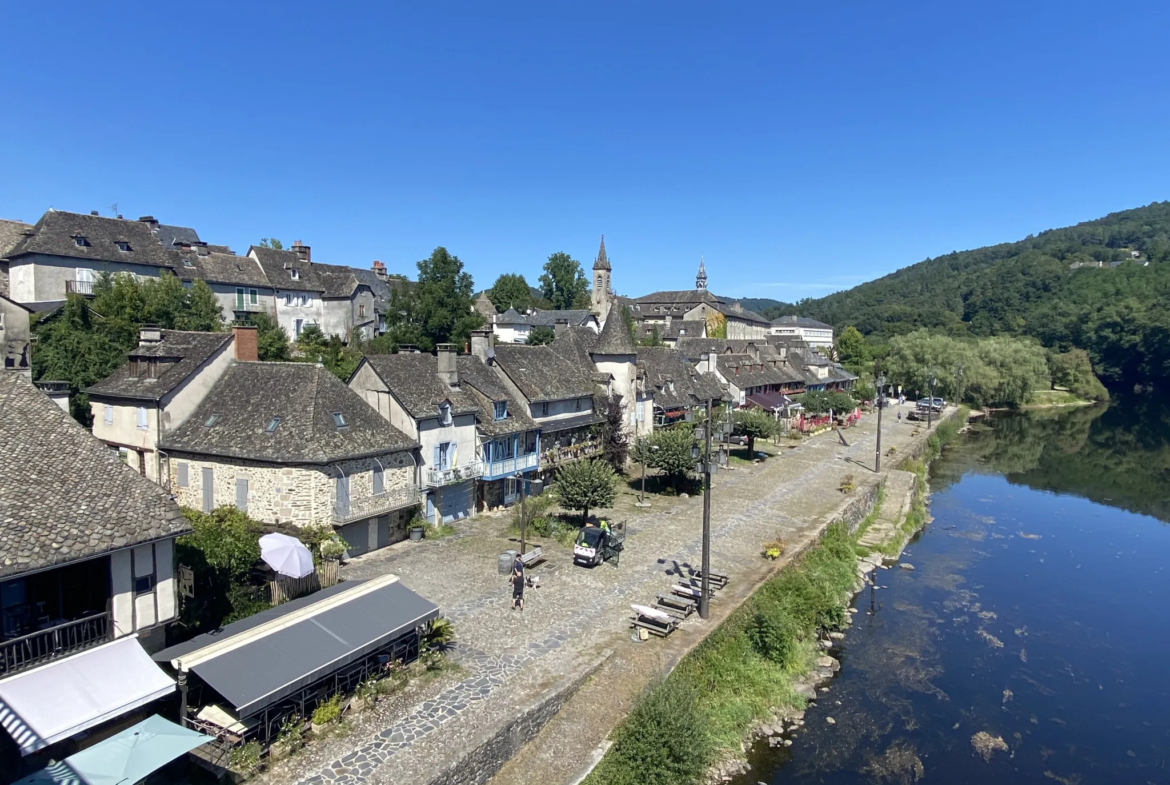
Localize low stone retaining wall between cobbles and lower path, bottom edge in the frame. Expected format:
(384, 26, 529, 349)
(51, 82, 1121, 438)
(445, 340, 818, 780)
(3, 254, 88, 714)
(427, 649, 613, 785)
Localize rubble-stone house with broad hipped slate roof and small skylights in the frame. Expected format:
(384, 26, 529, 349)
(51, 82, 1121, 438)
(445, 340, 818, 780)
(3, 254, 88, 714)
(159, 363, 418, 555)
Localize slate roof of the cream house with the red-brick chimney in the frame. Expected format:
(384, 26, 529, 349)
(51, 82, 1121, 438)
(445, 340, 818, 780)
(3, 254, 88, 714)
(85, 330, 232, 401)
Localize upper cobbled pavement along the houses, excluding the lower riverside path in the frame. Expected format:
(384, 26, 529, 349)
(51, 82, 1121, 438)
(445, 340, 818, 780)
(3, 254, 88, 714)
(278, 404, 945, 785)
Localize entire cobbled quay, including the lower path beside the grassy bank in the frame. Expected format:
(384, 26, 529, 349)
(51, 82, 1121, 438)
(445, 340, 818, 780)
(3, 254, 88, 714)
(262, 404, 945, 785)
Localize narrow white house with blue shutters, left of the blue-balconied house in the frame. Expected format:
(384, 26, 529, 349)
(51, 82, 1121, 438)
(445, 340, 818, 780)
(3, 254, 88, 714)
(349, 344, 483, 521)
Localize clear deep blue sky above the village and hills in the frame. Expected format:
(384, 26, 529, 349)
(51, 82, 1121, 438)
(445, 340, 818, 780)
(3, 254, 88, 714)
(0, 0, 1170, 299)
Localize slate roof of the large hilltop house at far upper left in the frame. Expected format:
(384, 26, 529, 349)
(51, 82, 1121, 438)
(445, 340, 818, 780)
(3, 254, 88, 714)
(9, 211, 179, 267)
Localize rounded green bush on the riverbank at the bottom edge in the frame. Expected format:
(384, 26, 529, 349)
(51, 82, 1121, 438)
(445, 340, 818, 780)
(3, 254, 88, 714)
(590, 682, 711, 785)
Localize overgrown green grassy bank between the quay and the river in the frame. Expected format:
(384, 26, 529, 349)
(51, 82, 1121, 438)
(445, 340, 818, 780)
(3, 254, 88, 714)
(575, 409, 966, 785)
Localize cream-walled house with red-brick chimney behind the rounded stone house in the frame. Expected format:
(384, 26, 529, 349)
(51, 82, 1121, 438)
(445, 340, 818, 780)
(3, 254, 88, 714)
(85, 326, 256, 484)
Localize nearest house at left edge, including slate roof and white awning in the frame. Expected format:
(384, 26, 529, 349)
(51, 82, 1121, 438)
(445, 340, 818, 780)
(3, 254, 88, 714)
(0, 373, 191, 776)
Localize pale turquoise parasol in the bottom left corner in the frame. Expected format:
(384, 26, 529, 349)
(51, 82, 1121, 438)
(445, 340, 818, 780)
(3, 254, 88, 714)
(15, 716, 214, 785)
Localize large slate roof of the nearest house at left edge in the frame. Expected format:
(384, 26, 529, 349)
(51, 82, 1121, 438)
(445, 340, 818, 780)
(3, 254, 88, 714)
(0, 373, 191, 578)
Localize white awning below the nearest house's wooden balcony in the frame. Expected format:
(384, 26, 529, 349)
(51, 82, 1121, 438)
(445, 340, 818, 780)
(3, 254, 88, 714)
(0, 636, 174, 755)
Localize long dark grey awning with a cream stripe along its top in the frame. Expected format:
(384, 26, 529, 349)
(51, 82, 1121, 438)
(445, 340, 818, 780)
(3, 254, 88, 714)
(154, 576, 439, 718)
